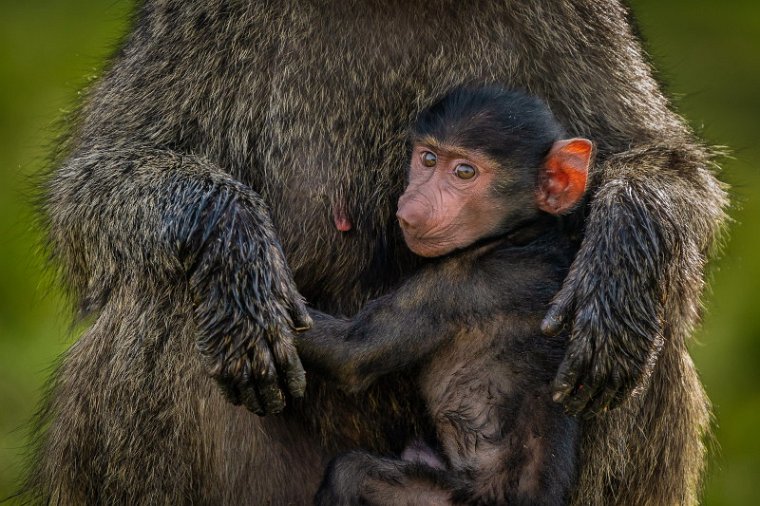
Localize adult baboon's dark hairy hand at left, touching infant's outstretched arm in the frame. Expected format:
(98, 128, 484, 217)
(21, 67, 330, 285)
(186, 186, 311, 415)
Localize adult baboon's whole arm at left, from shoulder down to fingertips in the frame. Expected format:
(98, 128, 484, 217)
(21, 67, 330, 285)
(44, 2, 308, 413)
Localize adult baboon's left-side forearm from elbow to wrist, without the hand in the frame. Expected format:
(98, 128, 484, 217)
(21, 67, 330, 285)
(44, 146, 277, 312)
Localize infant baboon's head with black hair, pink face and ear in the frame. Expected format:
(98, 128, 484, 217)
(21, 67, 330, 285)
(397, 87, 592, 257)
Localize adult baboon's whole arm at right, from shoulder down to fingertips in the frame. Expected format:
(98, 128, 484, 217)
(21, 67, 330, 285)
(504, 0, 727, 413)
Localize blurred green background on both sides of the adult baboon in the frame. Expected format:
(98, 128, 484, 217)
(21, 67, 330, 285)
(0, 0, 760, 505)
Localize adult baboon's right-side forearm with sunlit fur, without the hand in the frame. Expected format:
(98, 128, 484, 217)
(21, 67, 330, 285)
(582, 144, 729, 336)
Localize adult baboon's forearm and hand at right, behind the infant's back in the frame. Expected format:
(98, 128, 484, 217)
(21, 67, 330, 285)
(545, 145, 727, 412)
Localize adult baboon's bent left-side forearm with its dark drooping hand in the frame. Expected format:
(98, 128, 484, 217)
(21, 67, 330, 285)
(45, 146, 310, 413)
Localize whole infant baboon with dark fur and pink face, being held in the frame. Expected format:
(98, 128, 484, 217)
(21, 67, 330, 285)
(298, 87, 592, 505)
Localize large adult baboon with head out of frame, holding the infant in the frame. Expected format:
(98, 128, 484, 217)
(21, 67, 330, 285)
(23, 0, 727, 505)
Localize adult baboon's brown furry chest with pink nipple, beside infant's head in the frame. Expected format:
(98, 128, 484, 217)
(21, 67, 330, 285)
(259, 2, 512, 311)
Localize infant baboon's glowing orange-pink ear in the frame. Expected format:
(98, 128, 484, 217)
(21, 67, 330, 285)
(536, 138, 594, 214)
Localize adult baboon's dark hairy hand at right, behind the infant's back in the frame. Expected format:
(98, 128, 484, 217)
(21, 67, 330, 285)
(541, 180, 665, 416)
